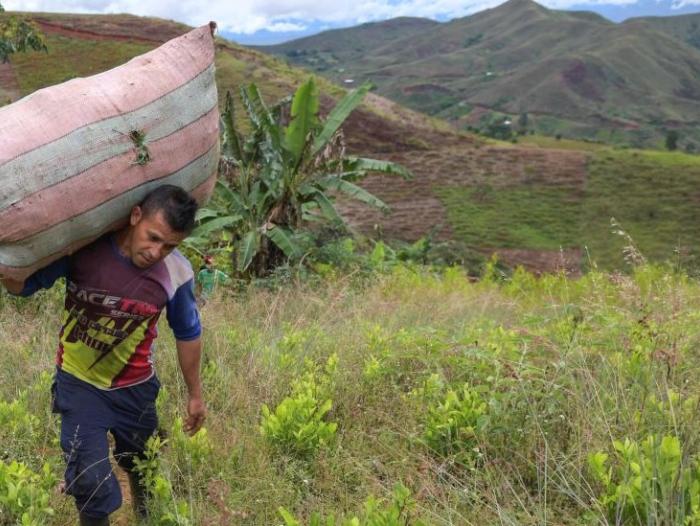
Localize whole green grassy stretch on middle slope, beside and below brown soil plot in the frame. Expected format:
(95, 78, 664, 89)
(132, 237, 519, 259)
(435, 145, 700, 269)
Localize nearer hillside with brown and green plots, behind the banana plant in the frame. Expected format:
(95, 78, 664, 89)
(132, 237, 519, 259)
(0, 13, 700, 271)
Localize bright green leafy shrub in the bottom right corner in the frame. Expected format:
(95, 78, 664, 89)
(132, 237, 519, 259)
(588, 435, 700, 526)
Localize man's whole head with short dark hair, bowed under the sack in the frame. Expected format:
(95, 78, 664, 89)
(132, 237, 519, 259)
(119, 185, 197, 268)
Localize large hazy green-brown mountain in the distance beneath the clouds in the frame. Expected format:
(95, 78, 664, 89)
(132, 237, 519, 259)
(259, 0, 700, 148)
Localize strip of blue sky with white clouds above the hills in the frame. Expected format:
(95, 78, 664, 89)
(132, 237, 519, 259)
(0, 0, 700, 44)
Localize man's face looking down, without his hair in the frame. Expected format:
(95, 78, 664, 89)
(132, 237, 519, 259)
(129, 206, 187, 268)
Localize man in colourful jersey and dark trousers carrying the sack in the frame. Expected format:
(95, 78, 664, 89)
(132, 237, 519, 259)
(2, 185, 206, 526)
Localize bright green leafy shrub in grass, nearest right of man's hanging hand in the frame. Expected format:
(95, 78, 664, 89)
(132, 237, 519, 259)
(260, 355, 338, 458)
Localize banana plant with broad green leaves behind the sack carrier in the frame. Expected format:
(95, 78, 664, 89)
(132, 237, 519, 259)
(193, 78, 412, 275)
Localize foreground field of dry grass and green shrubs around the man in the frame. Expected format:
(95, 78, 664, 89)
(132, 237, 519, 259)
(0, 266, 700, 526)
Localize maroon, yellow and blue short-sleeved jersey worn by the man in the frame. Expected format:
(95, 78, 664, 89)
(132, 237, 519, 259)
(21, 235, 201, 389)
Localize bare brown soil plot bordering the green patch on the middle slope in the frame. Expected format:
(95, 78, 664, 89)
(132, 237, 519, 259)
(339, 142, 587, 253)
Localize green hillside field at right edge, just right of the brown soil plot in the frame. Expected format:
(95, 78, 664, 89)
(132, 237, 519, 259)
(582, 151, 700, 268)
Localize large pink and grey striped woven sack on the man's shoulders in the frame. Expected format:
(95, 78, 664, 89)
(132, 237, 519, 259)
(0, 25, 219, 280)
